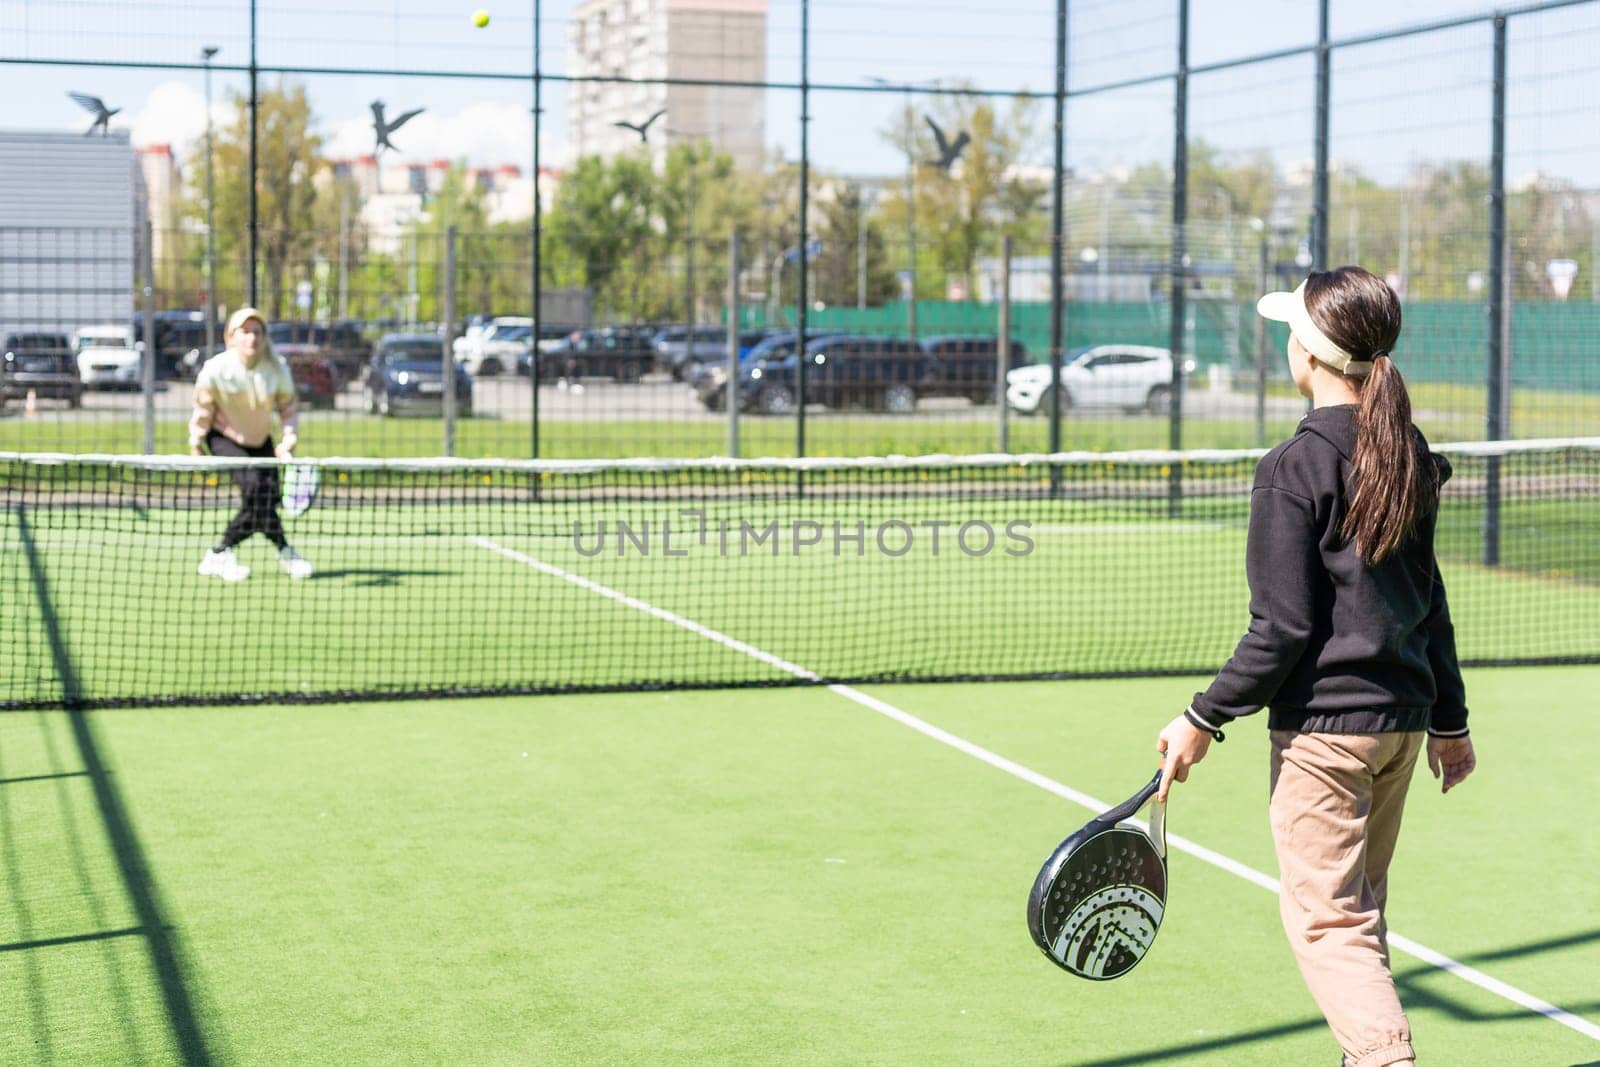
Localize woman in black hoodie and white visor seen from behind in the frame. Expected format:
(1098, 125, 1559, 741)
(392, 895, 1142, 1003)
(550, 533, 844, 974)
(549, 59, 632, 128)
(1157, 267, 1475, 1067)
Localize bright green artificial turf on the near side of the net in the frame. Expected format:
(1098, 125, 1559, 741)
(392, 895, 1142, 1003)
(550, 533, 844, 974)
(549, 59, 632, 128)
(0, 669, 1600, 1065)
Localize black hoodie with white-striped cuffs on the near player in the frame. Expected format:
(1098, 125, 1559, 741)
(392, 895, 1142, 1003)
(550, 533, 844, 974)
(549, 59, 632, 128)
(1187, 405, 1467, 736)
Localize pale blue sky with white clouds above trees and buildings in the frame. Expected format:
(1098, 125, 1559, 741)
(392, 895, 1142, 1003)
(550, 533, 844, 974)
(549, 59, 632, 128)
(0, 0, 1600, 184)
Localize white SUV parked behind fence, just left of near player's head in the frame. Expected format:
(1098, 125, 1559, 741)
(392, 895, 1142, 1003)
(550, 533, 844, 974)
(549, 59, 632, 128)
(1005, 344, 1194, 414)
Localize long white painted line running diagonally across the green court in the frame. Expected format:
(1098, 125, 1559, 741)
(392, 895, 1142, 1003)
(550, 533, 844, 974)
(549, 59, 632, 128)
(472, 537, 1600, 1041)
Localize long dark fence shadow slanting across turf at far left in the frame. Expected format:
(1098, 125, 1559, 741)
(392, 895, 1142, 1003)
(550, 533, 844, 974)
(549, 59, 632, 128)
(16, 509, 211, 1065)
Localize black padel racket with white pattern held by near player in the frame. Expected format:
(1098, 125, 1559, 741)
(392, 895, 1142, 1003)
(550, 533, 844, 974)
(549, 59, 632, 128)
(1027, 771, 1166, 982)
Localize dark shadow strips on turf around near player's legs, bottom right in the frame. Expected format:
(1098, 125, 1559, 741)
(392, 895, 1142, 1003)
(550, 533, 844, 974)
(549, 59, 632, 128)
(1061, 929, 1600, 1067)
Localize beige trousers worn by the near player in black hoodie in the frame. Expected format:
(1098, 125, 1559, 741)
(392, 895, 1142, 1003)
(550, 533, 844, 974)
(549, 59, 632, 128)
(1272, 729, 1424, 1067)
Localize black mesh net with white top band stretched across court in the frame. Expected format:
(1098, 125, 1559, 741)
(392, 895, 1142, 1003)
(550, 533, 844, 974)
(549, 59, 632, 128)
(0, 438, 1600, 709)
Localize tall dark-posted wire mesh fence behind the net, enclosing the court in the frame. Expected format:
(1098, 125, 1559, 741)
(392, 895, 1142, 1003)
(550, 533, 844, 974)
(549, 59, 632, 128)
(0, 0, 1600, 458)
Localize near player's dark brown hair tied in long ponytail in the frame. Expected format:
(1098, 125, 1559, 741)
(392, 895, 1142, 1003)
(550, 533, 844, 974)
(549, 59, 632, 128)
(1306, 267, 1438, 565)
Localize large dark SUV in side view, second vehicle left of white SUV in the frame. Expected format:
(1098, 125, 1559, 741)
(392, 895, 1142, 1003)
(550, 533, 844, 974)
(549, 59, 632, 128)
(741, 334, 928, 414)
